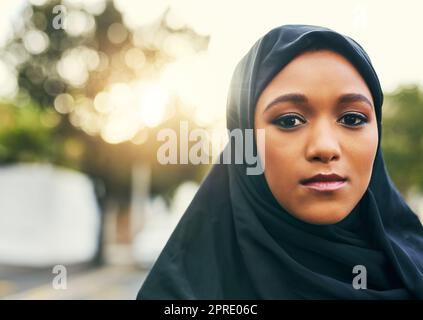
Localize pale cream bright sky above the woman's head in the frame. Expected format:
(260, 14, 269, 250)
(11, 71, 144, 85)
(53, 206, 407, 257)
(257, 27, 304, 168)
(115, 0, 423, 91)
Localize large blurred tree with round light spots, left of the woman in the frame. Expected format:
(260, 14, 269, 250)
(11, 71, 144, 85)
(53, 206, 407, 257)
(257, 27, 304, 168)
(0, 0, 209, 203)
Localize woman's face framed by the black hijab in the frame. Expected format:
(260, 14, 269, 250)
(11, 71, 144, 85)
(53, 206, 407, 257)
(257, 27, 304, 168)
(254, 50, 378, 224)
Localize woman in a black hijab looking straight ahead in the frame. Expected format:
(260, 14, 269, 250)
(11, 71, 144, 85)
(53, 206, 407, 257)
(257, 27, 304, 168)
(138, 25, 423, 299)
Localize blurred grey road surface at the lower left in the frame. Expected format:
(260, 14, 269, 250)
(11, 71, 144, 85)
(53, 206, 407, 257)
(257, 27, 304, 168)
(0, 265, 147, 300)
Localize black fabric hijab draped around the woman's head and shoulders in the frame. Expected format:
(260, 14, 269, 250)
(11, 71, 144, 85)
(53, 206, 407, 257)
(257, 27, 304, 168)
(137, 25, 423, 299)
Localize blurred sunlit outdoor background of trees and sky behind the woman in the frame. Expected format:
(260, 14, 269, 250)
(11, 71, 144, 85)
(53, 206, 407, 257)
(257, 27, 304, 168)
(0, 0, 423, 299)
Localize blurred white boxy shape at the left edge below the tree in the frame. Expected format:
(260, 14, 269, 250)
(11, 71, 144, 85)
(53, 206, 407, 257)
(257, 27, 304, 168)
(0, 164, 100, 266)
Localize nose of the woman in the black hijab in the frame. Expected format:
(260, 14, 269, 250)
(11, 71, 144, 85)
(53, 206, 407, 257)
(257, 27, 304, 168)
(306, 124, 340, 163)
